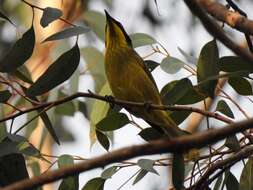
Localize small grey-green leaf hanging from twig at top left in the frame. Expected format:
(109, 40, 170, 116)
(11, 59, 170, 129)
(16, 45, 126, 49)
(40, 7, 62, 28)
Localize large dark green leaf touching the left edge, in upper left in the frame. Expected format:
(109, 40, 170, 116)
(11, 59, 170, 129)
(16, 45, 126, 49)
(0, 26, 35, 73)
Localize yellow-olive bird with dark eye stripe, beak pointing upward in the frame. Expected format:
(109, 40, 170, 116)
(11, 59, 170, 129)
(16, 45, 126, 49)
(105, 11, 182, 137)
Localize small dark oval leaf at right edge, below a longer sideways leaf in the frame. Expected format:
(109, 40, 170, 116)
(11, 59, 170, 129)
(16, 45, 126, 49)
(228, 77, 252, 96)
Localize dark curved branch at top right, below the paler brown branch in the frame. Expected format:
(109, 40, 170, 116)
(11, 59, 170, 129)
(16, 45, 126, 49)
(184, 0, 253, 62)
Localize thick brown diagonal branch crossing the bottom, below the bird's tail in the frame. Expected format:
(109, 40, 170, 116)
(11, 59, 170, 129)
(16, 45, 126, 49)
(1, 119, 253, 190)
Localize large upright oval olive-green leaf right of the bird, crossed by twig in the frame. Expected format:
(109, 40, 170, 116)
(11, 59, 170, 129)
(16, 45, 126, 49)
(197, 40, 219, 98)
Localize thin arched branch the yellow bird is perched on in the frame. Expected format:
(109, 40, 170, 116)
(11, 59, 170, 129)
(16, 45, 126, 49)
(0, 92, 233, 124)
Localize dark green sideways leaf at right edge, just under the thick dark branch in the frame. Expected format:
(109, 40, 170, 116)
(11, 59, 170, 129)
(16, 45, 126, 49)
(219, 56, 253, 73)
